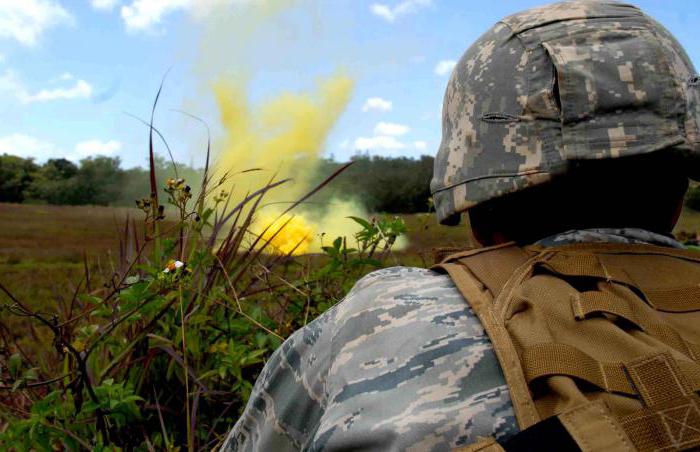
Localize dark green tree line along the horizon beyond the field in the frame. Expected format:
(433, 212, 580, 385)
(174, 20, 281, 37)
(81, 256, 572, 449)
(0, 154, 433, 213)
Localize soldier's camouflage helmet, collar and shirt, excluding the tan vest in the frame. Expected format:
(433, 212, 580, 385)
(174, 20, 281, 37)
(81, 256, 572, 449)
(224, 1, 700, 451)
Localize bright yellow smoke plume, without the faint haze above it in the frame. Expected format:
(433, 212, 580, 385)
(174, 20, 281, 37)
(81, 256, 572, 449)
(214, 75, 372, 254)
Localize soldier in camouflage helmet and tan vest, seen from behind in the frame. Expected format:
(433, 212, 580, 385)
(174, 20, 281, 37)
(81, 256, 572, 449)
(225, 1, 700, 451)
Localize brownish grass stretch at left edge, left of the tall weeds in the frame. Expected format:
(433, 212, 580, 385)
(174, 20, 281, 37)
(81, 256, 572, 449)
(0, 203, 143, 306)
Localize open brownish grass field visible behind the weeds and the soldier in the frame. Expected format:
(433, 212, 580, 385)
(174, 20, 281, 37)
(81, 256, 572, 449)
(0, 203, 700, 308)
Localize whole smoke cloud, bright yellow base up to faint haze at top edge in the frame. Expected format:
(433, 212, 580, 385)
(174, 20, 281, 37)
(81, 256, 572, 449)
(191, 0, 378, 254)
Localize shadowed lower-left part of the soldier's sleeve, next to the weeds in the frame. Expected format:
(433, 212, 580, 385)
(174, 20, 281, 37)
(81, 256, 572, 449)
(222, 298, 334, 451)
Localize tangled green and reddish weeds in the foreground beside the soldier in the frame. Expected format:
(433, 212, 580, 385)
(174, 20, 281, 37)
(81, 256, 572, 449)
(0, 90, 405, 451)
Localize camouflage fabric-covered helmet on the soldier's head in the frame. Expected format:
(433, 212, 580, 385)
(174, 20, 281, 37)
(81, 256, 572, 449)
(430, 1, 700, 224)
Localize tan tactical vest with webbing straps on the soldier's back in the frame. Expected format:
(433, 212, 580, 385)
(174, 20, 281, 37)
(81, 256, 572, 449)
(434, 243, 700, 452)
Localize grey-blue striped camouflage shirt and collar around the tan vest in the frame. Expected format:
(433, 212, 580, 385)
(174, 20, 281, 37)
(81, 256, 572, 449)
(222, 228, 681, 452)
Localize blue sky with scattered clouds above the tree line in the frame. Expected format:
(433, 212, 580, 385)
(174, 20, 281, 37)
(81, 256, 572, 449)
(0, 0, 700, 167)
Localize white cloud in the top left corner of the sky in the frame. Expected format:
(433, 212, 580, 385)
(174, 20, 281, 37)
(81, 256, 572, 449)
(0, 0, 73, 46)
